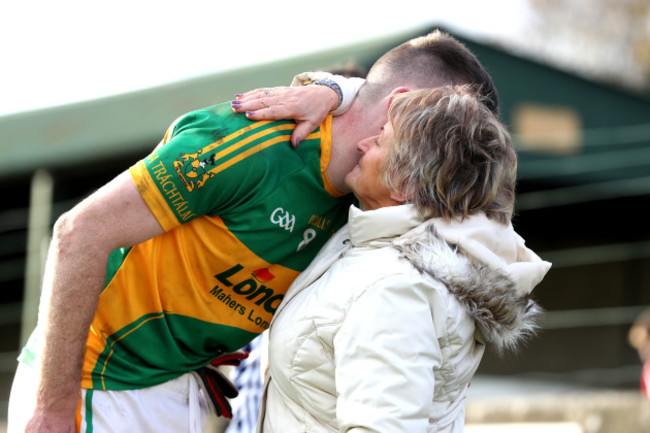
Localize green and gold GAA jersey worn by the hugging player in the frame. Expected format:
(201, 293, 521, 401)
(82, 104, 351, 389)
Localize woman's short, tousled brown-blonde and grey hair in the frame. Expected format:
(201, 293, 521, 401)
(384, 85, 517, 224)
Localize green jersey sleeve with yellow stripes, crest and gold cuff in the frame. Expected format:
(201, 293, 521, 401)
(131, 103, 294, 231)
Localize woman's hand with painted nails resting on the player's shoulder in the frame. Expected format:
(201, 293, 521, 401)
(231, 86, 339, 147)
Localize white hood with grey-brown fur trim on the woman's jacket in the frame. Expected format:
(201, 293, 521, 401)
(393, 210, 551, 352)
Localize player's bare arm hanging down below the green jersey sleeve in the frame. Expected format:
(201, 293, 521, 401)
(26, 172, 163, 433)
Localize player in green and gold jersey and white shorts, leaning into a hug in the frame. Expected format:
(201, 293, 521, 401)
(9, 32, 497, 433)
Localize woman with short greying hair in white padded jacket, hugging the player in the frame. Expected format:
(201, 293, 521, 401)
(253, 86, 550, 433)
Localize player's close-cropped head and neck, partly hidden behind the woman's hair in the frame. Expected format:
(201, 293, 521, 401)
(328, 30, 499, 191)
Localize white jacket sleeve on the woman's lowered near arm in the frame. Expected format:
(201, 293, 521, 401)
(334, 276, 441, 433)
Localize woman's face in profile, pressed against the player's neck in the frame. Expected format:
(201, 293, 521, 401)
(345, 122, 401, 210)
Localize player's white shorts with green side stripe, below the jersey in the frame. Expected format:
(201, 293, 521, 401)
(7, 363, 214, 433)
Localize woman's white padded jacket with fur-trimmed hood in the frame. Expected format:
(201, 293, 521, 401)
(258, 205, 550, 433)
